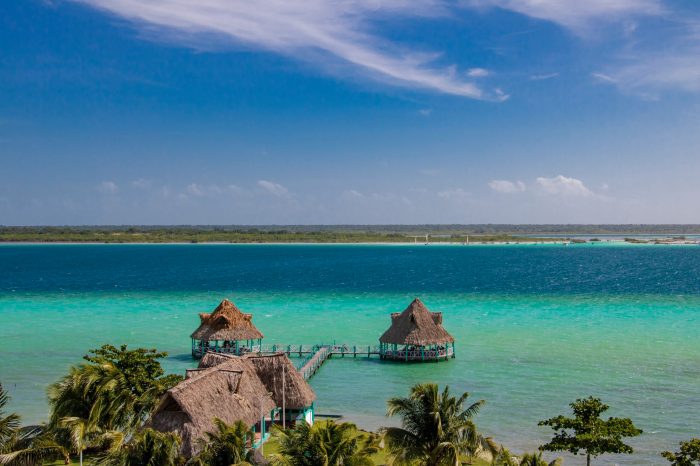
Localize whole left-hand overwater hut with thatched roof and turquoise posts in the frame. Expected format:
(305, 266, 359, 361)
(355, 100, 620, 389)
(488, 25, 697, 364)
(190, 299, 263, 357)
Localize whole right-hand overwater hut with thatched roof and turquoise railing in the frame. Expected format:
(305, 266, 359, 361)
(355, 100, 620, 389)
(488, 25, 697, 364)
(379, 298, 455, 361)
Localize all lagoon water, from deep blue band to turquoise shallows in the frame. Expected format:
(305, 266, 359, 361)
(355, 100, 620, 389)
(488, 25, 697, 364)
(0, 245, 700, 465)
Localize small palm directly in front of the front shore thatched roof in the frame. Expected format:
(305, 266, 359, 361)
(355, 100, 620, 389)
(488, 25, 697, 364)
(191, 418, 255, 466)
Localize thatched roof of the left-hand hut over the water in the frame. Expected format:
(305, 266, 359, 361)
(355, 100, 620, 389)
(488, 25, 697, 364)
(190, 299, 263, 341)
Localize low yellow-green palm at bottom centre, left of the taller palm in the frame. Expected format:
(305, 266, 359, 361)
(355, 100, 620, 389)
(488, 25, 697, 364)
(270, 421, 378, 466)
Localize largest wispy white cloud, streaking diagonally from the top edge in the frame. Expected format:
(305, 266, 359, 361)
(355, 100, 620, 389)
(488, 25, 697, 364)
(74, 0, 504, 100)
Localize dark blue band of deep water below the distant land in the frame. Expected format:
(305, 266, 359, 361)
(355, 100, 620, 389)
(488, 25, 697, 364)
(0, 245, 700, 295)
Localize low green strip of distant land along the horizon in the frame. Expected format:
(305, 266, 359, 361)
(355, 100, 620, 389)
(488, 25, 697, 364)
(0, 224, 700, 243)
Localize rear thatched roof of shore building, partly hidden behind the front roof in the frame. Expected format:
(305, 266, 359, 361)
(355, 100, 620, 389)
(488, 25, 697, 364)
(199, 352, 316, 409)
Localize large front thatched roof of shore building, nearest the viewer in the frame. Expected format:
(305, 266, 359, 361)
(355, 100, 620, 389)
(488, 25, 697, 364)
(149, 358, 275, 457)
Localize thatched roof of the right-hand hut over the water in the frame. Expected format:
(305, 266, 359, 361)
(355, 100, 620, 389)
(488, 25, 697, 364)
(379, 298, 455, 346)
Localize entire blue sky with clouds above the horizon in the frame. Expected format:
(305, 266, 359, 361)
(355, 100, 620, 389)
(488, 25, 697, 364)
(0, 0, 700, 225)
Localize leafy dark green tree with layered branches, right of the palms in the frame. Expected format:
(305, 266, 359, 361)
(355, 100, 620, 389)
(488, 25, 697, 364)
(539, 397, 642, 466)
